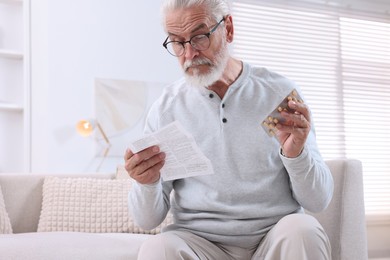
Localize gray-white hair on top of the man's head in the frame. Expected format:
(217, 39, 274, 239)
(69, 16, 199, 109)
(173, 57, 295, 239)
(161, 0, 230, 28)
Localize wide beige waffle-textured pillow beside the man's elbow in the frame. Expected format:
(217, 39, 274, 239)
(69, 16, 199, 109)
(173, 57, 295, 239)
(38, 177, 171, 234)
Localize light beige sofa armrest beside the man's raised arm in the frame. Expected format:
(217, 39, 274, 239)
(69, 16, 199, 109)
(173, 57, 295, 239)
(309, 159, 368, 260)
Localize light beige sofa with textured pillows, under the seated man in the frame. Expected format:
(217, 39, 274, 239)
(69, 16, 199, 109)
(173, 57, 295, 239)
(0, 159, 367, 260)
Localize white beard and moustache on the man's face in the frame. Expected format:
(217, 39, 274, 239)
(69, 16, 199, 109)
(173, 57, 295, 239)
(183, 36, 229, 88)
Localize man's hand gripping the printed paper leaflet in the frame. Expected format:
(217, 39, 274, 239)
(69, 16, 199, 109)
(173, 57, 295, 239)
(124, 145, 165, 184)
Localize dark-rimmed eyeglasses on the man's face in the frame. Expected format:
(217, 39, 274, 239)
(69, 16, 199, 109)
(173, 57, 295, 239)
(163, 18, 225, 57)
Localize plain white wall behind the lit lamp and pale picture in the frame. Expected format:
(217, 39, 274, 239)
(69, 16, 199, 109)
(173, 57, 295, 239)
(31, 0, 181, 173)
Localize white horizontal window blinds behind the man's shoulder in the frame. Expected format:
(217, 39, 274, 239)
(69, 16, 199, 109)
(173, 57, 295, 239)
(232, 1, 390, 218)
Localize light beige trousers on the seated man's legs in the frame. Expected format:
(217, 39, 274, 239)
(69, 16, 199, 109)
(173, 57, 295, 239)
(138, 214, 331, 260)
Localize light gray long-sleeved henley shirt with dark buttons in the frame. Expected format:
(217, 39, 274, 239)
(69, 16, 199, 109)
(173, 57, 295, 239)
(129, 63, 333, 248)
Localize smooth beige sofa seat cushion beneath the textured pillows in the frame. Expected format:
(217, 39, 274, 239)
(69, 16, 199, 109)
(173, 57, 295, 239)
(0, 232, 150, 260)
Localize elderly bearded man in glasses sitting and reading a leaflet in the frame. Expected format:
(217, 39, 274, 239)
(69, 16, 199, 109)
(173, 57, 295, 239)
(124, 0, 333, 260)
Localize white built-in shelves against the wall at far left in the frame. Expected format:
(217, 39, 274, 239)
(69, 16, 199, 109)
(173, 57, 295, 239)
(0, 0, 31, 173)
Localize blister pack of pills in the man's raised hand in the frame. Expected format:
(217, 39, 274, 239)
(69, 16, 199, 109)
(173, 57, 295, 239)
(261, 89, 303, 137)
